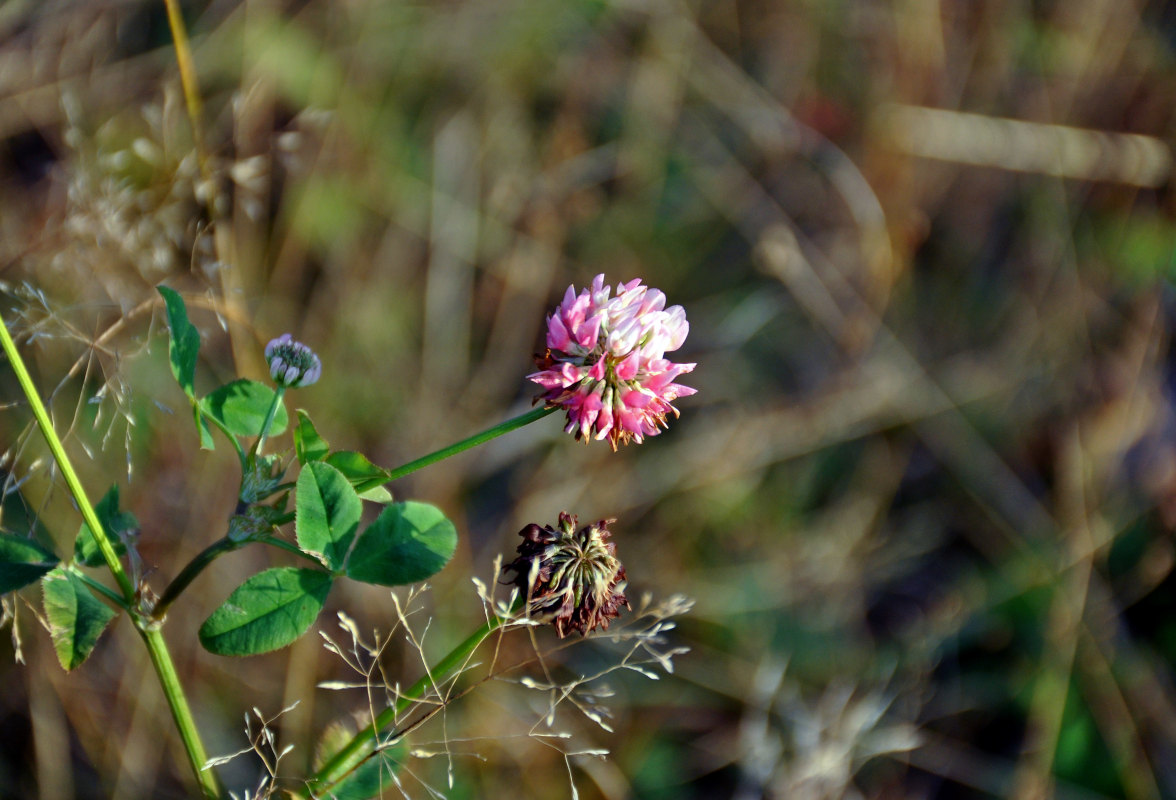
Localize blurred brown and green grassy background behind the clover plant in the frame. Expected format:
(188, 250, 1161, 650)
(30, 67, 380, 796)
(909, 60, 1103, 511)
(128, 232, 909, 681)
(0, 0, 1176, 800)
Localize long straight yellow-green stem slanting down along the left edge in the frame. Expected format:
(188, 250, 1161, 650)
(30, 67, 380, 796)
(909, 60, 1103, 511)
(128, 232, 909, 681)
(0, 316, 221, 799)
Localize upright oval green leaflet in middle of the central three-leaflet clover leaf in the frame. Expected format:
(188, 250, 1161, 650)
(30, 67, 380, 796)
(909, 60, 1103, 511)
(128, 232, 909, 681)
(294, 461, 363, 573)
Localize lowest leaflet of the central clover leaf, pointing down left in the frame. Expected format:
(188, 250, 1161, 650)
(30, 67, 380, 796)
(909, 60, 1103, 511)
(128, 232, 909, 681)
(200, 567, 330, 655)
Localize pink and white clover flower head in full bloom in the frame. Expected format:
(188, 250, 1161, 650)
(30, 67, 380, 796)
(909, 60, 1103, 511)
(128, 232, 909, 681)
(527, 275, 695, 451)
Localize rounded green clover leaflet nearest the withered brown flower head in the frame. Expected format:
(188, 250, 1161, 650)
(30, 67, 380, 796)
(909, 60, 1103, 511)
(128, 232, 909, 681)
(347, 500, 457, 586)
